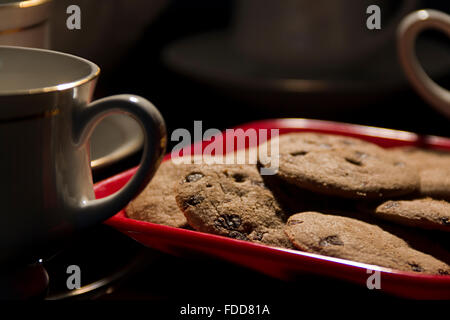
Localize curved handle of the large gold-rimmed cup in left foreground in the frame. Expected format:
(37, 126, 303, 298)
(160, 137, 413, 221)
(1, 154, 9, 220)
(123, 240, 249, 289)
(73, 94, 167, 228)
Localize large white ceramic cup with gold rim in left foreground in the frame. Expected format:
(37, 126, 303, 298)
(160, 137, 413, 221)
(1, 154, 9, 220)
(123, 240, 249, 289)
(0, 46, 166, 265)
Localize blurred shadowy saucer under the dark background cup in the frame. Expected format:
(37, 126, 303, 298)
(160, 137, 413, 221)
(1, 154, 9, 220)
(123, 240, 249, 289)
(163, 32, 450, 109)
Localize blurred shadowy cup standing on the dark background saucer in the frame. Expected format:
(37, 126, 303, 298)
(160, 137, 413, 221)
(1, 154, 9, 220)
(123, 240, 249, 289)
(232, 0, 417, 70)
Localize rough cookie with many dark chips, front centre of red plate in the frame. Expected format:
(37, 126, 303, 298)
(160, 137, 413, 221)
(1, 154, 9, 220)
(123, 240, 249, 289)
(176, 165, 289, 246)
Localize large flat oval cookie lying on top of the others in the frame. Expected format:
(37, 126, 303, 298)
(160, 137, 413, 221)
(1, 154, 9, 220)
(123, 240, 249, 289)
(259, 133, 419, 199)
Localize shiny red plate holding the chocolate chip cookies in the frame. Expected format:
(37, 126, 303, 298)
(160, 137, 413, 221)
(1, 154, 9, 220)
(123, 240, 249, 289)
(95, 119, 450, 299)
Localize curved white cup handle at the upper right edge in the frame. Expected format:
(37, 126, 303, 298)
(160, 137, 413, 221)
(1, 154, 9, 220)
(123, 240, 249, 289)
(397, 9, 450, 117)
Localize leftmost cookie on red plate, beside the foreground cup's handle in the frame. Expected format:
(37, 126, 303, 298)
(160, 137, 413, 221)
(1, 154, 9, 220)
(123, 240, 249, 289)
(125, 160, 191, 228)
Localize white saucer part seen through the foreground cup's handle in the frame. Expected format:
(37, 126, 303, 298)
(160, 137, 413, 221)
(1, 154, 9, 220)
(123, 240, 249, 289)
(90, 115, 144, 170)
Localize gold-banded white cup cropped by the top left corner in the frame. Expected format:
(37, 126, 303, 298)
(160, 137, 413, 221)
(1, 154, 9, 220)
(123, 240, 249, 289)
(0, 0, 51, 49)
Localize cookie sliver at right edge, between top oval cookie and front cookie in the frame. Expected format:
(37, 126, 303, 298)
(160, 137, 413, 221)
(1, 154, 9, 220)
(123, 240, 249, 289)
(373, 198, 450, 231)
